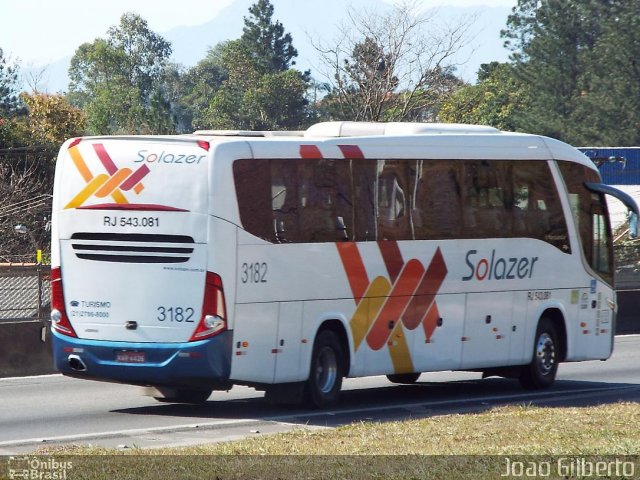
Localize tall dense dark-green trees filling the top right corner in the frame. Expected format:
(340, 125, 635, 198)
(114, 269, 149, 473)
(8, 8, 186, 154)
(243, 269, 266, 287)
(502, 0, 640, 146)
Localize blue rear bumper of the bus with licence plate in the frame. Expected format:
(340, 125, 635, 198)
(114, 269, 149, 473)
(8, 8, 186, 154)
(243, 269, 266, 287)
(52, 331, 232, 389)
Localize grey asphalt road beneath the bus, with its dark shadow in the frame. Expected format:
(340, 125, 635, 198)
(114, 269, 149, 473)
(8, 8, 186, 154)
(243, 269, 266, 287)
(0, 335, 640, 455)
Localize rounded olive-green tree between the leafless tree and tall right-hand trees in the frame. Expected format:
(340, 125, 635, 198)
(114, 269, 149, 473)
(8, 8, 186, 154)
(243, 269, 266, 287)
(439, 62, 530, 131)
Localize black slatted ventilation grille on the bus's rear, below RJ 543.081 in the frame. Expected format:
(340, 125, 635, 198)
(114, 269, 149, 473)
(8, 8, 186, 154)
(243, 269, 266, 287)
(71, 233, 195, 263)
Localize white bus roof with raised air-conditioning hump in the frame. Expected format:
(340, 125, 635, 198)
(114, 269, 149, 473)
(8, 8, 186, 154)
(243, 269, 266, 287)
(67, 121, 597, 171)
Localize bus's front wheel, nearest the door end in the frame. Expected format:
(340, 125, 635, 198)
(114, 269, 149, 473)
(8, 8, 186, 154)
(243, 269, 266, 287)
(519, 317, 560, 390)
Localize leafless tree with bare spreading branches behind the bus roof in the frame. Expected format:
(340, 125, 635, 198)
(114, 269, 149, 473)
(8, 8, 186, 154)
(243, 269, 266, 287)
(316, 3, 473, 121)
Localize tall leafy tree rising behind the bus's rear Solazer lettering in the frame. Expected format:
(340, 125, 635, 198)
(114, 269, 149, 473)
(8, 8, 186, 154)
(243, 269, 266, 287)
(69, 13, 173, 134)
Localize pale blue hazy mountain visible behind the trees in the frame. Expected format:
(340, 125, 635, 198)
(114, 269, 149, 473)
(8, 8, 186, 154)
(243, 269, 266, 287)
(25, 0, 510, 92)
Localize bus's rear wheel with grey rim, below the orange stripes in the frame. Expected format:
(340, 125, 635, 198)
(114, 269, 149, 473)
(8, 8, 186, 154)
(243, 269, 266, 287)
(305, 330, 344, 408)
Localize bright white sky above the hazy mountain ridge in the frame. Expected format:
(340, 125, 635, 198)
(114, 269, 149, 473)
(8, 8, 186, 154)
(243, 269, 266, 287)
(0, 0, 517, 68)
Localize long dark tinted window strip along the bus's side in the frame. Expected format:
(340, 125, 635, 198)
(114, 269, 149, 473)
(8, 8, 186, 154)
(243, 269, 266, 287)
(234, 159, 568, 252)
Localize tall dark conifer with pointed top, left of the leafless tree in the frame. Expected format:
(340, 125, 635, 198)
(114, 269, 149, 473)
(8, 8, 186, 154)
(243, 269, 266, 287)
(240, 0, 298, 73)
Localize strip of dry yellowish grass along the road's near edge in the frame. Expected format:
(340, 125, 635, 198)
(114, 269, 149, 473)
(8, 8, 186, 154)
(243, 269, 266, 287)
(16, 403, 640, 479)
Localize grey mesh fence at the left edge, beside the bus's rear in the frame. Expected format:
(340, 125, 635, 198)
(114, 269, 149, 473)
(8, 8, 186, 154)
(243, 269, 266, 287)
(0, 264, 51, 323)
